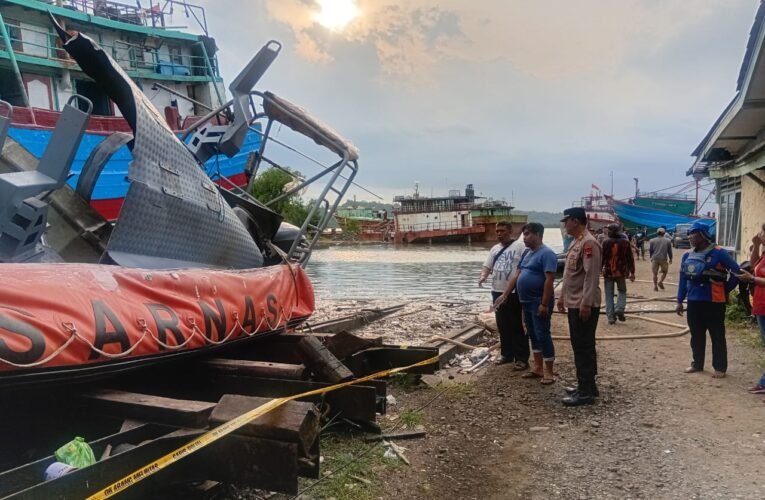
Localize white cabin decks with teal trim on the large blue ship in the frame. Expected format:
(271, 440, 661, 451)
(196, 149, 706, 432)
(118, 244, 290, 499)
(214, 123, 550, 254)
(0, 0, 225, 132)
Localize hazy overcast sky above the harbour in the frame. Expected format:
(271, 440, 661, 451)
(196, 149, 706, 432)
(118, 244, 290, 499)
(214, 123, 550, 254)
(194, 0, 758, 211)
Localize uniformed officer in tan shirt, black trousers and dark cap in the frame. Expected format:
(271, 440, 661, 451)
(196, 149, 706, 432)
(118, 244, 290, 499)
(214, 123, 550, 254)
(558, 207, 602, 406)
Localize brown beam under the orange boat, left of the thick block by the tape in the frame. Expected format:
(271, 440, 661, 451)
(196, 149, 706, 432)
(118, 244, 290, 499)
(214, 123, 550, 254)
(81, 389, 215, 428)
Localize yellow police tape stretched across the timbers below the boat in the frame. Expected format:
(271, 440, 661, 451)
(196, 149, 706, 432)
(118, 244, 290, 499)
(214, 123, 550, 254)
(88, 356, 438, 500)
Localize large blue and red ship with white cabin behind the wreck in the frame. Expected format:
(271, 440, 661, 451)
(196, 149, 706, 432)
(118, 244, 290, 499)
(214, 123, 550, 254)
(0, 0, 261, 220)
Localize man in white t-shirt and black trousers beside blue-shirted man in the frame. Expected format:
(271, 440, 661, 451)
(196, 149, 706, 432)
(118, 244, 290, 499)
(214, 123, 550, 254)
(478, 221, 530, 371)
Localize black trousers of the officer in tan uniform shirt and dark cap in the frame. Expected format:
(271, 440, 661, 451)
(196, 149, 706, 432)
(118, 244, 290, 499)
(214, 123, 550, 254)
(568, 307, 600, 396)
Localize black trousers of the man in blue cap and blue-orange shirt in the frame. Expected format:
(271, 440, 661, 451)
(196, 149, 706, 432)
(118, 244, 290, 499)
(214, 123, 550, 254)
(687, 302, 728, 372)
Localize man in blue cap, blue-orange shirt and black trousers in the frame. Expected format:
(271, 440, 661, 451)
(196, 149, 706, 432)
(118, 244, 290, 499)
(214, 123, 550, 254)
(675, 221, 741, 378)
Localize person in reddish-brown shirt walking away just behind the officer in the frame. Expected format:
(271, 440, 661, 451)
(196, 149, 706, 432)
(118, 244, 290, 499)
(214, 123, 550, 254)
(603, 224, 635, 325)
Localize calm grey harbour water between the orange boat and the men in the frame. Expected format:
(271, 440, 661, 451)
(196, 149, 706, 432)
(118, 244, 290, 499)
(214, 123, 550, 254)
(307, 229, 562, 300)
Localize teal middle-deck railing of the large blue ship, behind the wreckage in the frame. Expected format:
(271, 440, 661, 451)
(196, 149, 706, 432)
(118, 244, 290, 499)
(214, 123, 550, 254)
(0, 24, 220, 79)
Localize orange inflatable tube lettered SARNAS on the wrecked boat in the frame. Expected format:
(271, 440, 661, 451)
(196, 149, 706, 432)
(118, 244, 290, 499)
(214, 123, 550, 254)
(0, 264, 314, 382)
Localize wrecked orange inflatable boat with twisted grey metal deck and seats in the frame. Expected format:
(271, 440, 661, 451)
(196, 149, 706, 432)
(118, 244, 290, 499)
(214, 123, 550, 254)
(0, 18, 358, 389)
